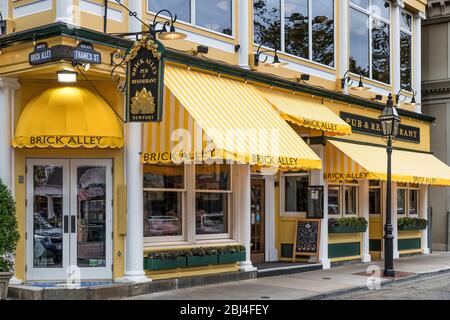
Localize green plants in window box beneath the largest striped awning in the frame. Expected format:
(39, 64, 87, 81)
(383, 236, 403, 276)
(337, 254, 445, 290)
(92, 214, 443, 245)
(147, 245, 245, 260)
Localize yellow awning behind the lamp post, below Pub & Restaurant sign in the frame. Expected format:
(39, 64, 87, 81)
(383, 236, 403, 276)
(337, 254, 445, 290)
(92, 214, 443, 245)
(324, 140, 450, 186)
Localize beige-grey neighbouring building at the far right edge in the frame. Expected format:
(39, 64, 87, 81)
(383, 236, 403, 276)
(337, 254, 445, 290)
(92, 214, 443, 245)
(422, 1, 450, 250)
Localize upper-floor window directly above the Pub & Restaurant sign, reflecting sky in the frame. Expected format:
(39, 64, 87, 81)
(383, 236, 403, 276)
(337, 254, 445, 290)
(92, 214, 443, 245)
(349, 0, 391, 84)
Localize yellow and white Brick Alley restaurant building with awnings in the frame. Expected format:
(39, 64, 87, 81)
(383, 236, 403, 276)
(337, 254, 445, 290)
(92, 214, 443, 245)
(0, 0, 444, 281)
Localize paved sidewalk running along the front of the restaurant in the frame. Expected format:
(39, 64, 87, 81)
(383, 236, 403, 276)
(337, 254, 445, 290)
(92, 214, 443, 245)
(125, 252, 450, 300)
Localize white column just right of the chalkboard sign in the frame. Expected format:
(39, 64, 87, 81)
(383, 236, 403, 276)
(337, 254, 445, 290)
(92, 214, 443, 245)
(310, 145, 331, 269)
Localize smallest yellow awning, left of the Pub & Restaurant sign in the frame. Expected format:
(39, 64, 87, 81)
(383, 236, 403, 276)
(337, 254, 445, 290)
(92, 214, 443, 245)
(258, 87, 352, 136)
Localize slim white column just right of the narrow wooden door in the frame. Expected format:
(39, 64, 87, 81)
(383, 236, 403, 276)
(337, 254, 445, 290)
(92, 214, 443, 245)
(264, 175, 278, 261)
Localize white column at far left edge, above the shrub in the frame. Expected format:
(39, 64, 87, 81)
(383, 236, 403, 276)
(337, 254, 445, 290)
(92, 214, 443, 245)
(0, 78, 19, 190)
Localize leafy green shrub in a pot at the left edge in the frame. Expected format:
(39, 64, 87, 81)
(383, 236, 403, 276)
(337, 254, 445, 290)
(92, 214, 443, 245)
(0, 180, 19, 300)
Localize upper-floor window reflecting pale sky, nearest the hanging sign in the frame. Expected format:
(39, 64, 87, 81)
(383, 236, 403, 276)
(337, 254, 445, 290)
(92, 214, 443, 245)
(148, 0, 233, 35)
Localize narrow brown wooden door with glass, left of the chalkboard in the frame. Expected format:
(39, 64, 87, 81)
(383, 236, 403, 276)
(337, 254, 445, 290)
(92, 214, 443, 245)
(250, 178, 265, 263)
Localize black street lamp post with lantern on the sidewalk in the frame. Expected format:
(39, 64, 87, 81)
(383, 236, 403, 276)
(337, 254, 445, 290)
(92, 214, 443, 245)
(378, 94, 400, 277)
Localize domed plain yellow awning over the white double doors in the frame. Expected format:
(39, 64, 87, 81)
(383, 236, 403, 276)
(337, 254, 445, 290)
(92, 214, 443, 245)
(12, 86, 123, 148)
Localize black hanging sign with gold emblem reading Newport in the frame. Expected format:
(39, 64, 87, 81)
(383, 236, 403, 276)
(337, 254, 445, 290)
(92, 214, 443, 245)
(126, 37, 164, 122)
